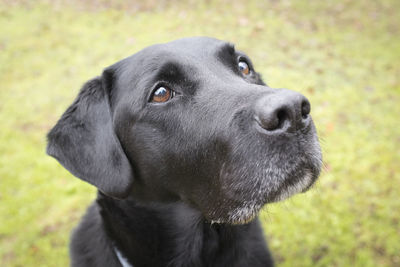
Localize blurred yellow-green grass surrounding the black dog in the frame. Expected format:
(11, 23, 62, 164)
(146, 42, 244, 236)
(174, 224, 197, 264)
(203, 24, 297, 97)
(0, 0, 400, 266)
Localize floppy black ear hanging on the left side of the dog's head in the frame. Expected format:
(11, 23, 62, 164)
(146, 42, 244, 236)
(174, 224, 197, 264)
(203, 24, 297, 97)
(47, 70, 133, 198)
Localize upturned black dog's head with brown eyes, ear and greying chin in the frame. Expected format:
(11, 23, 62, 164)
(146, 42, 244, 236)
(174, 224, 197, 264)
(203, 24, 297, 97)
(47, 37, 321, 223)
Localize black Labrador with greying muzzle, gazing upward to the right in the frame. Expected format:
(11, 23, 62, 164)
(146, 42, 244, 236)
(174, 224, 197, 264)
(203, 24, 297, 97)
(47, 37, 321, 267)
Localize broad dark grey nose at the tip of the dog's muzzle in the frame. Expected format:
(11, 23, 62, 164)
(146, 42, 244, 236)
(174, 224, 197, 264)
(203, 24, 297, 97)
(255, 89, 311, 133)
